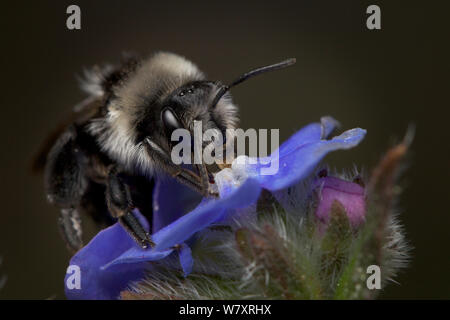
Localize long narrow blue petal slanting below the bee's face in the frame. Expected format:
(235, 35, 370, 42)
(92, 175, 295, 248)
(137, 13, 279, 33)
(106, 179, 261, 268)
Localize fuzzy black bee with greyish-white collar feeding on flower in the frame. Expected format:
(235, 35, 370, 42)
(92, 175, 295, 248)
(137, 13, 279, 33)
(34, 52, 295, 251)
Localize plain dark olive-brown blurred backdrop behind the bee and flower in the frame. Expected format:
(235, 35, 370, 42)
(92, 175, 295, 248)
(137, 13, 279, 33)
(0, 0, 450, 299)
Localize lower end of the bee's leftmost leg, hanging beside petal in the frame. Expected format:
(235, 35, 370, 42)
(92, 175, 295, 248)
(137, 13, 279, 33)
(58, 208, 83, 253)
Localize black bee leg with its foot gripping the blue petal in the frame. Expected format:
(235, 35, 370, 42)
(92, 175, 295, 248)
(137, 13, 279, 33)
(106, 168, 154, 249)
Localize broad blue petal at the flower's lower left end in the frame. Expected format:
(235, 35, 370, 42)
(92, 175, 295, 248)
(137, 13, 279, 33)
(64, 211, 148, 299)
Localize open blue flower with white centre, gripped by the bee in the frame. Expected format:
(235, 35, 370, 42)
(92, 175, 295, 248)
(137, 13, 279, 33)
(65, 117, 366, 299)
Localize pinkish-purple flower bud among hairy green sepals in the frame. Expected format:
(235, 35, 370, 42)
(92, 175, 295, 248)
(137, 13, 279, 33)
(313, 176, 366, 228)
